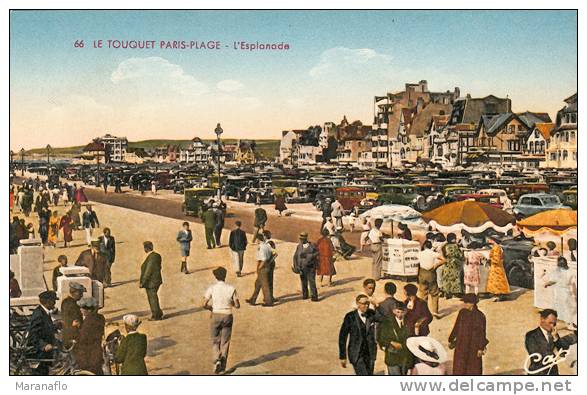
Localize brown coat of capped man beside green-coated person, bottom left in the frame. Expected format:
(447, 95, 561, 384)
(73, 312, 106, 375)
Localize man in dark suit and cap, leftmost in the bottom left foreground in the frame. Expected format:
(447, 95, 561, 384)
(29, 291, 57, 376)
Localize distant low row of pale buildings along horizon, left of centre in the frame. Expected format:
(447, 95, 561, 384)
(77, 134, 257, 165)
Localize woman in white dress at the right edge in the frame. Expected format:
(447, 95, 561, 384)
(544, 256, 577, 324)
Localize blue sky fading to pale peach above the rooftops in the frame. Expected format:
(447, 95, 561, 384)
(10, 11, 577, 150)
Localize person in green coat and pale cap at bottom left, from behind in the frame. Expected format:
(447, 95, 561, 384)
(114, 314, 149, 376)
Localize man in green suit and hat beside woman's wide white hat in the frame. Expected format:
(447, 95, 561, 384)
(377, 302, 413, 376)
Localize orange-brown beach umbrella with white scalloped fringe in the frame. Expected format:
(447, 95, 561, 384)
(422, 200, 515, 233)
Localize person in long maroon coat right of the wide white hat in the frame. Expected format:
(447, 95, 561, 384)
(448, 293, 489, 376)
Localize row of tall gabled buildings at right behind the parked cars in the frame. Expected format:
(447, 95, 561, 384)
(279, 80, 577, 168)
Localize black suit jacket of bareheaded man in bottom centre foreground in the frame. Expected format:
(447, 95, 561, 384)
(338, 309, 377, 365)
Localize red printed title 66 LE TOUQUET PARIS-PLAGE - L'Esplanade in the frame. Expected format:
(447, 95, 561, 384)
(90, 39, 290, 52)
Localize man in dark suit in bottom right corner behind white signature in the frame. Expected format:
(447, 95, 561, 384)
(525, 309, 576, 376)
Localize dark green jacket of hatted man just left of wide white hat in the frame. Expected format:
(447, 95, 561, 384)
(377, 315, 413, 368)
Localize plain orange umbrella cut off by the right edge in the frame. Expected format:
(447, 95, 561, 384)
(517, 208, 577, 253)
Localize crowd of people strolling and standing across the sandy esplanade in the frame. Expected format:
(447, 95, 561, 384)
(10, 176, 577, 375)
